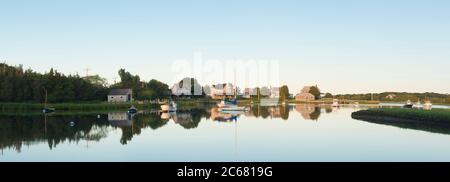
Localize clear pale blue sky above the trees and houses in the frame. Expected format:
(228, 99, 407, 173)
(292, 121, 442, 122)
(0, 0, 450, 93)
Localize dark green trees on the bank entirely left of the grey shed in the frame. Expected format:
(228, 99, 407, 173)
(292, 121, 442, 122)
(0, 64, 108, 103)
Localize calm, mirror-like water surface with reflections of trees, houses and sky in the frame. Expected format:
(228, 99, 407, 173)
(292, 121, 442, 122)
(0, 105, 450, 162)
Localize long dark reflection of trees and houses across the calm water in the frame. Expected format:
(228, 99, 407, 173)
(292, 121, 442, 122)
(0, 105, 333, 152)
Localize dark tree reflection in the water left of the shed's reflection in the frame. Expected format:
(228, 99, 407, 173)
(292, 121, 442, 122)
(0, 115, 109, 152)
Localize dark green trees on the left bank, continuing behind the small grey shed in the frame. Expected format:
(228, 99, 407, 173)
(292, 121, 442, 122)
(0, 64, 170, 103)
